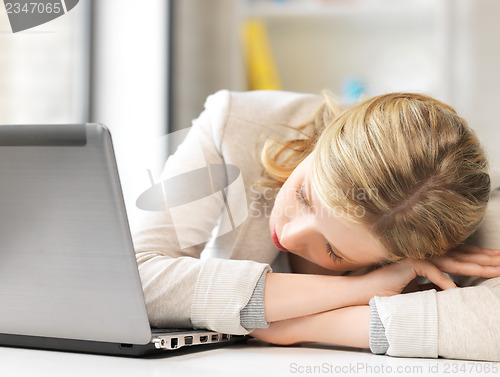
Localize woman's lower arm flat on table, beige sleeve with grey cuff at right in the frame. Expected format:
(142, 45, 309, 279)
(258, 260, 500, 361)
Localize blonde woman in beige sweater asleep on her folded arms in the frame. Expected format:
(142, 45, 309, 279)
(134, 91, 500, 359)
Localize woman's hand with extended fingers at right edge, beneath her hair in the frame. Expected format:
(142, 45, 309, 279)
(430, 245, 500, 278)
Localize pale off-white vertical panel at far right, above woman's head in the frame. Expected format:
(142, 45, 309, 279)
(452, 0, 500, 169)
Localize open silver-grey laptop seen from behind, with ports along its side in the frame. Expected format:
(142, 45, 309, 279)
(0, 124, 246, 356)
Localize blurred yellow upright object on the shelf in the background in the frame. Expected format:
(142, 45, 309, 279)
(242, 19, 282, 90)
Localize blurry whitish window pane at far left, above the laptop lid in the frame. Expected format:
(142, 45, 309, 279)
(0, 0, 90, 124)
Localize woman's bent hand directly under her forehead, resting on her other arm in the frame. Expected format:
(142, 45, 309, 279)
(361, 258, 457, 297)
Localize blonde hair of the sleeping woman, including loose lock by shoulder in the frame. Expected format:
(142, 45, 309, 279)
(261, 93, 490, 260)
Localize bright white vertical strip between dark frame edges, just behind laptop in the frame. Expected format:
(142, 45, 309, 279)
(91, 0, 168, 228)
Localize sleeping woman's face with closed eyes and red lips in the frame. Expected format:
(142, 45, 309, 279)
(269, 154, 387, 271)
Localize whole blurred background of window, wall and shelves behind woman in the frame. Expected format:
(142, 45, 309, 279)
(0, 0, 500, 227)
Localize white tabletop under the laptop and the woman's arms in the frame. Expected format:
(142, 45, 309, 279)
(0, 340, 500, 377)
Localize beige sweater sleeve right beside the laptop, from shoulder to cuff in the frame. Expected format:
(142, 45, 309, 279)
(133, 91, 269, 334)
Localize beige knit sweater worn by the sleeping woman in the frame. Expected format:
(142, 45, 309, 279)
(133, 91, 500, 360)
